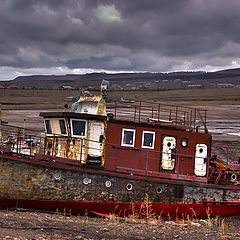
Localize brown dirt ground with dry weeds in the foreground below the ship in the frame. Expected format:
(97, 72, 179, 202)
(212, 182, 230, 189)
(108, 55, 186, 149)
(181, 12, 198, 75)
(0, 211, 240, 240)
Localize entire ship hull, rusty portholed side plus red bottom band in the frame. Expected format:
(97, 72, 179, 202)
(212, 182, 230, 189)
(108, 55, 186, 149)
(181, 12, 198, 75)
(0, 155, 240, 218)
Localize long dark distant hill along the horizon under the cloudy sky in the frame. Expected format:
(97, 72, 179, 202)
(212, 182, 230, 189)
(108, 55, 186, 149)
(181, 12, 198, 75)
(1, 68, 240, 90)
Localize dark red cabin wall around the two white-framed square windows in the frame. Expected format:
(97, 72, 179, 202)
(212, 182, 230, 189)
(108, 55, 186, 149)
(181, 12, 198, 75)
(105, 122, 211, 176)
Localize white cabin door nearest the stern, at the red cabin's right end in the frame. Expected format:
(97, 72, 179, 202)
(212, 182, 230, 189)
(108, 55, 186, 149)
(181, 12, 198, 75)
(194, 144, 207, 177)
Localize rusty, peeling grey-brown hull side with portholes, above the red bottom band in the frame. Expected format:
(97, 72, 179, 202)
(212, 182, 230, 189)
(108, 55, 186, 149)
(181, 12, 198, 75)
(0, 158, 240, 206)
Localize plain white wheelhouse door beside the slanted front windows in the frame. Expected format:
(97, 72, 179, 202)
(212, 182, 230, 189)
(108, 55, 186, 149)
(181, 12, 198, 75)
(88, 122, 104, 157)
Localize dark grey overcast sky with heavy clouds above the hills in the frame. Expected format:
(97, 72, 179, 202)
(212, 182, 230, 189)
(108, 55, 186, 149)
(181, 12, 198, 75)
(0, 0, 240, 80)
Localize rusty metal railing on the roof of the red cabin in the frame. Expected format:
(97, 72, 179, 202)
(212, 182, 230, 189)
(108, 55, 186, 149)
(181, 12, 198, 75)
(107, 100, 208, 133)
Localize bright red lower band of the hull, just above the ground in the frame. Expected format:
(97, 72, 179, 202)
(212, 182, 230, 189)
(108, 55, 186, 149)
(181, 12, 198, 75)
(0, 199, 240, 218)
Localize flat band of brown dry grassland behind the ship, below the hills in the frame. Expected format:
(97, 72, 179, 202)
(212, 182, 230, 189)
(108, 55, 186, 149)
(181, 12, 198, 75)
(0, 88, 240, 108)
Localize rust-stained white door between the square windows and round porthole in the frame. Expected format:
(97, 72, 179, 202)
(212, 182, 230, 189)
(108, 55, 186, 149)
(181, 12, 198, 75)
(161, 136, 176, 170)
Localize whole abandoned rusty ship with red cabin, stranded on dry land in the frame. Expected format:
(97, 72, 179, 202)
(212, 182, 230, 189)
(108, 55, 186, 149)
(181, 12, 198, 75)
(0, 86, 240, 218)
